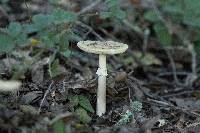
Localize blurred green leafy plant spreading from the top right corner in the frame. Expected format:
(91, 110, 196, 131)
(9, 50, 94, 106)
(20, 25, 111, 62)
(144, 0, 200, 53)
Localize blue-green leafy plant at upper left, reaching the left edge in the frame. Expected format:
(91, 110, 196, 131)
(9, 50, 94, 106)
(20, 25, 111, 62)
(0, 9, 80, 55)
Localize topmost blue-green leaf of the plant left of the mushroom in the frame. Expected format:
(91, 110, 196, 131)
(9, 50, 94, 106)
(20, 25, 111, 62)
(52, 9, 77, 23)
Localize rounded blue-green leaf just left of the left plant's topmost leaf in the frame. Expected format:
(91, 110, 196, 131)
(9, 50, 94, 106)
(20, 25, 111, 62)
(32, 14, 54, 31)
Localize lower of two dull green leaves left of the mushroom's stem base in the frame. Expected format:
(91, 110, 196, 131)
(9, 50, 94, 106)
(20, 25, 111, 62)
(75, 108, 92, 123)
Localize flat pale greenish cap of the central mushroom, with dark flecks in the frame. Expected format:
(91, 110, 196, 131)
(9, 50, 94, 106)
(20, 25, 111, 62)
(77, 41, 128, 55)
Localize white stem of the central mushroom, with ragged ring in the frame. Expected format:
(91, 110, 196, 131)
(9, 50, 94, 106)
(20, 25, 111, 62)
(96, 54, 107, 116)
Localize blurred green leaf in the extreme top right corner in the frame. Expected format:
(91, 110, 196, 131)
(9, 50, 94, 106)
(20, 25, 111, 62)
(183, 0, 200, 27)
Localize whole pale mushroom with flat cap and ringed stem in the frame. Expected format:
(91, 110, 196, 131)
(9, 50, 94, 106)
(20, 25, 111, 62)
(77, 41, 128, 116)
